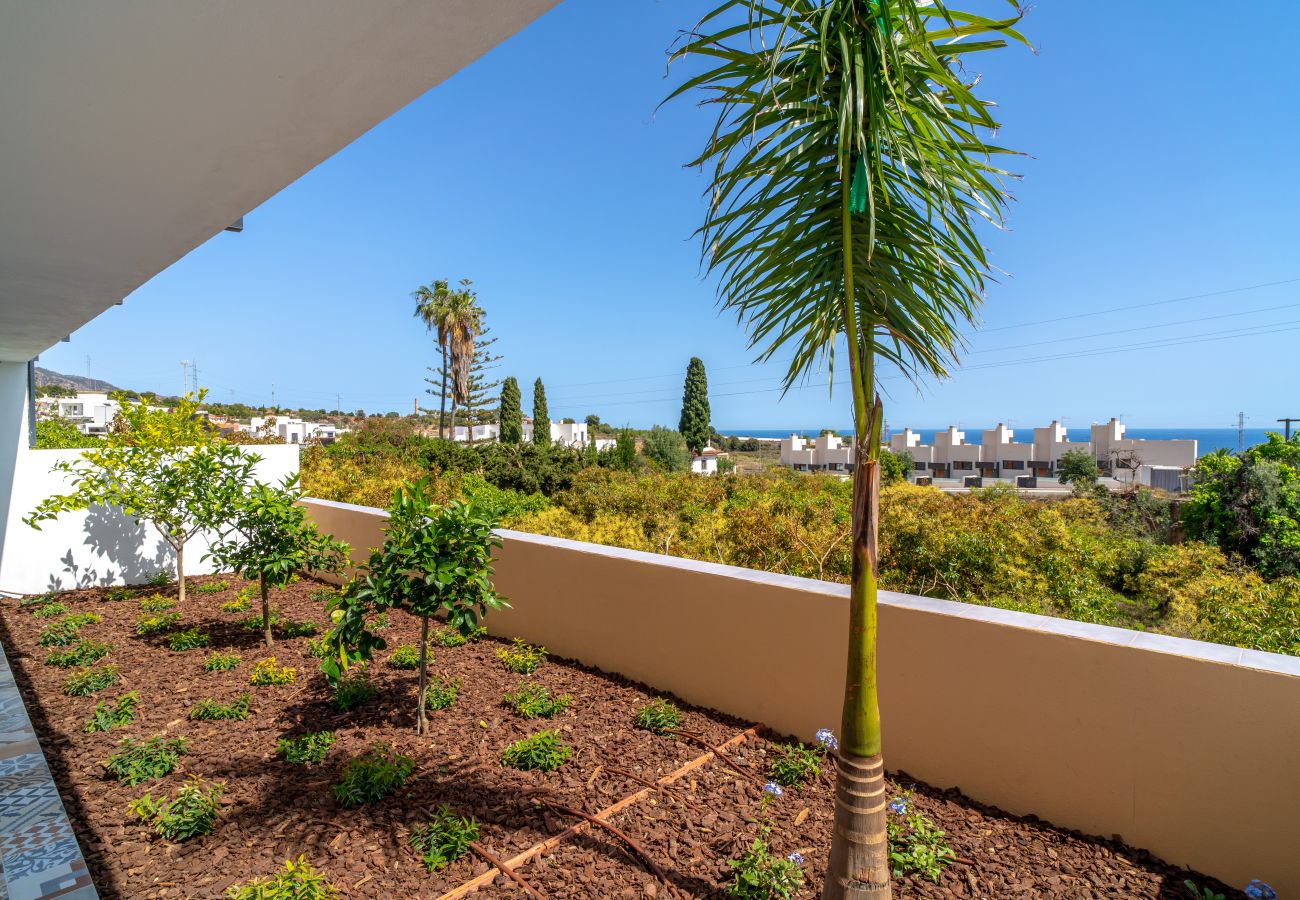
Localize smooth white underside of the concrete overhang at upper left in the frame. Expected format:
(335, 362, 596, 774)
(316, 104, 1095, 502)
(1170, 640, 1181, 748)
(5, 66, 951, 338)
(0, 0, 558, 362)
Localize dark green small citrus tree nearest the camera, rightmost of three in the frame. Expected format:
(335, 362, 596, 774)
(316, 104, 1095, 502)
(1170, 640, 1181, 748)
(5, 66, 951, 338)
(321, 479, 508, 735)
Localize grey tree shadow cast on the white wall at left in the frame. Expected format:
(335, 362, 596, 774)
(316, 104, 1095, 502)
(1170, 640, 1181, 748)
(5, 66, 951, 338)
(48, 506, 176, 590)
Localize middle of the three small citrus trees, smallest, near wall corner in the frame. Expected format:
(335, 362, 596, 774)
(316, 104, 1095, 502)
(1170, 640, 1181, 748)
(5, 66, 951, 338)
(204, 473, 348, 646)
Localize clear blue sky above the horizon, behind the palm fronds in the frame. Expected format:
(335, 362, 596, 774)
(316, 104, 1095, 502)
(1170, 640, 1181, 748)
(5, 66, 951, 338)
(40, 0, 1300, 430)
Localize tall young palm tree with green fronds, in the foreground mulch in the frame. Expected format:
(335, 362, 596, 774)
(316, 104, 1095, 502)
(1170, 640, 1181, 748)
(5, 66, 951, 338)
(670, 0, 1023, 900)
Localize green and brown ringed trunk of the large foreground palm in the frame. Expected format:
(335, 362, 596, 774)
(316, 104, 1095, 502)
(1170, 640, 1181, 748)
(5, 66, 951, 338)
(822, 169, 893, 900)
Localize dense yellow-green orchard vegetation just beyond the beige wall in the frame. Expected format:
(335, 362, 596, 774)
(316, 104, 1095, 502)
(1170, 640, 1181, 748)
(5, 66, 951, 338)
(303, 433, 1300, 654)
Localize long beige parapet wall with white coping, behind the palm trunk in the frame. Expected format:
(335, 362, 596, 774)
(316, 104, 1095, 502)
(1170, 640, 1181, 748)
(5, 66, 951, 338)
(306, 501, 1300, 897)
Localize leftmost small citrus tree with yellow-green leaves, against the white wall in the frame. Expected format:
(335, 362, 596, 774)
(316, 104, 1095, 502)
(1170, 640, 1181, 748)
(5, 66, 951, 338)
(23, 391, 254, 602)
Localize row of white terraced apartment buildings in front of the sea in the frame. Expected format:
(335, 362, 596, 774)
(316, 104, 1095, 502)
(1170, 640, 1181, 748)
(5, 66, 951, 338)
(781, 419, 1196, 484)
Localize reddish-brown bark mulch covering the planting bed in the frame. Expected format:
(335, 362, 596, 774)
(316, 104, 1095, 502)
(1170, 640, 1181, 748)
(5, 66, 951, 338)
(0, 576, 1243, 899)
